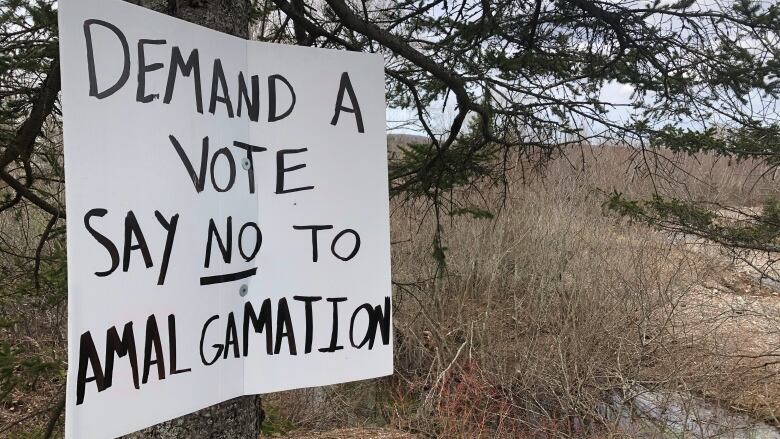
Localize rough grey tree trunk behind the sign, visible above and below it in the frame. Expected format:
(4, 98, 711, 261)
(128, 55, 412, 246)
(117, 0, 263, 439)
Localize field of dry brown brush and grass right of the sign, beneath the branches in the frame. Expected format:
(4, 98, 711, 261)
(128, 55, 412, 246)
(267, 148, 780, 437)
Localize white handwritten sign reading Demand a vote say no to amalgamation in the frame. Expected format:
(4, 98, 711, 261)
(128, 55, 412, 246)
(59, 0, 392, 438)
